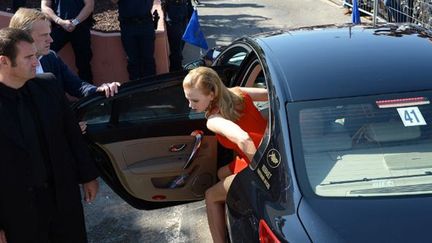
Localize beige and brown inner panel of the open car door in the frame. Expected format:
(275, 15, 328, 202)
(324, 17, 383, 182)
(99, 136, 217, 201)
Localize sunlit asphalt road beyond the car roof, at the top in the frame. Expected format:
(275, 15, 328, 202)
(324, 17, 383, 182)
(183, 0, 351, 63)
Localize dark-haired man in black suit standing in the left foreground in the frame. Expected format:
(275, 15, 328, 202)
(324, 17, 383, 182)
(0, 28, 98, 243)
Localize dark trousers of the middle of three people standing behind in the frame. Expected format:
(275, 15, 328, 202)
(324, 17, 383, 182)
(120, 20, 156, 80)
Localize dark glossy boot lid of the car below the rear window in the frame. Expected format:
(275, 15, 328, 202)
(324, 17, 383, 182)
(299, 196, 432, 242)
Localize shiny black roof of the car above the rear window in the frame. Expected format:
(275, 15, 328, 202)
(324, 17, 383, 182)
(250, 25, 432, 101)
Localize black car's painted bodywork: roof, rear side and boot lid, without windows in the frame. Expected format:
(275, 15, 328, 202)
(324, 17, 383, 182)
(226, 25, 432, 242)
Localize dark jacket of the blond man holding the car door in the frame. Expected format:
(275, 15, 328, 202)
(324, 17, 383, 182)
(40, 51, 96, 98)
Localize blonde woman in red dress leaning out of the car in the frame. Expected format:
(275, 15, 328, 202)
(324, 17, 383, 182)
(183, 67, 268, 243)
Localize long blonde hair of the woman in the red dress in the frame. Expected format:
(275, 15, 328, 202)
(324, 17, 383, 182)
(183, 67, 244, 121)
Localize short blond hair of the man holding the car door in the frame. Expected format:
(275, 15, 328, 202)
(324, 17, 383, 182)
(9, 8, 49, 34)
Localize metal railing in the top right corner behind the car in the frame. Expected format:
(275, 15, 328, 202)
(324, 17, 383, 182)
(342, 0, 432, 29)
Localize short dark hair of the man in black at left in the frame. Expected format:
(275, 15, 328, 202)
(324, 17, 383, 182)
(0, 28, 34, 66)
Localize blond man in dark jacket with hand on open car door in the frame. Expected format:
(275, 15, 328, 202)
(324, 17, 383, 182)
(9, 8, 120, 98)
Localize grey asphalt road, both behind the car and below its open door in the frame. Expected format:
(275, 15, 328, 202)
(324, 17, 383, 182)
(84, 0, 350, 243)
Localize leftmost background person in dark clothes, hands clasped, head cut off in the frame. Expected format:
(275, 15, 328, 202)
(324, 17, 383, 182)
(41, 0, 94, 83)
